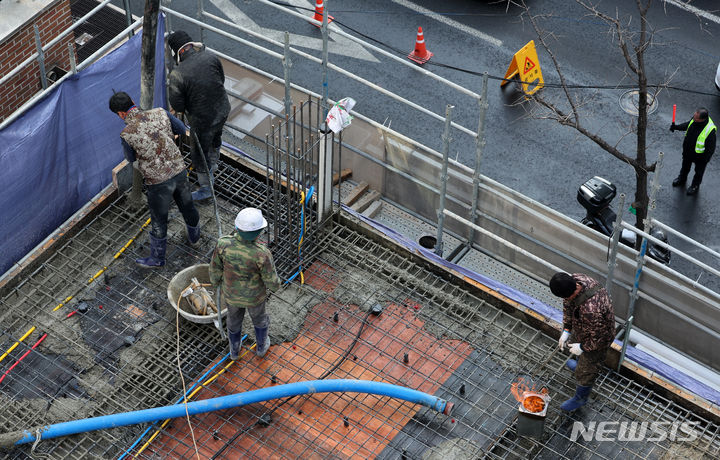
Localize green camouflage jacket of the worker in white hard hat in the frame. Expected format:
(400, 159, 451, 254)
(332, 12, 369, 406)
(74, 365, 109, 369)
(210, 233, 280, 308)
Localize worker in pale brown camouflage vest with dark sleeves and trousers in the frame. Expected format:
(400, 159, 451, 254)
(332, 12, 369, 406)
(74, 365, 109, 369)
(109, 91, 200, 268)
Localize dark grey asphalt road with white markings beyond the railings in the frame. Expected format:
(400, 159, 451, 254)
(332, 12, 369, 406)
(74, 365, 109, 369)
(133, 0, 720, 290)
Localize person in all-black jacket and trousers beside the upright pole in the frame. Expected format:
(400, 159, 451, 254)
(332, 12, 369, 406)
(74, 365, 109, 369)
(168, 30, 230, 200)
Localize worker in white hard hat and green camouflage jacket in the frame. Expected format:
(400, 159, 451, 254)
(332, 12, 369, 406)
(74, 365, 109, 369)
(210, 208, 280, 360)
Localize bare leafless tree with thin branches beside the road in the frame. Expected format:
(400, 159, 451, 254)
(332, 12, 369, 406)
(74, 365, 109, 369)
(522, 0, 655, 232)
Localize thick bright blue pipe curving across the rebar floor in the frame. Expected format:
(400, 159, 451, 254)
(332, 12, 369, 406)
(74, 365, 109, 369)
(7, 379, 453, 447)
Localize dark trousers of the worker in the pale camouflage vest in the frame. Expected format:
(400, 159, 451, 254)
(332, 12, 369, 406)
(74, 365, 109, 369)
(147, 170, 200, 239)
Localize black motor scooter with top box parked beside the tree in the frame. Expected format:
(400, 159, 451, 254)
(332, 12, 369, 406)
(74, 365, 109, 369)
(577, 176, 671, 265)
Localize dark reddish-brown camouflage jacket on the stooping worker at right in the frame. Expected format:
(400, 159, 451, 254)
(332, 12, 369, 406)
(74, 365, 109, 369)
(563, 273, 615, 351)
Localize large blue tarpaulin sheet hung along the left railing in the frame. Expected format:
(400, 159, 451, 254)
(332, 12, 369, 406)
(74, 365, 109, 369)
(0, 16, 167, 273)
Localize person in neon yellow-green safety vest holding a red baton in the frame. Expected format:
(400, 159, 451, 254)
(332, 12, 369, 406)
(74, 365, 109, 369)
(670, 107, 717, 195)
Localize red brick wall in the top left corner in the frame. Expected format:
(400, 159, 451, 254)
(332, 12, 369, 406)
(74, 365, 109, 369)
(0, 0, 75, 121)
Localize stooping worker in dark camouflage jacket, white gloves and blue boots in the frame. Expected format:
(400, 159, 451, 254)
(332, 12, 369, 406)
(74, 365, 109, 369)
(550, 272, 615, 411)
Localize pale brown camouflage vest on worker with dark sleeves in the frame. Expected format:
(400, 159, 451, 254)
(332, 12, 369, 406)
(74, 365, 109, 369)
(120, 108, 185, 185)
